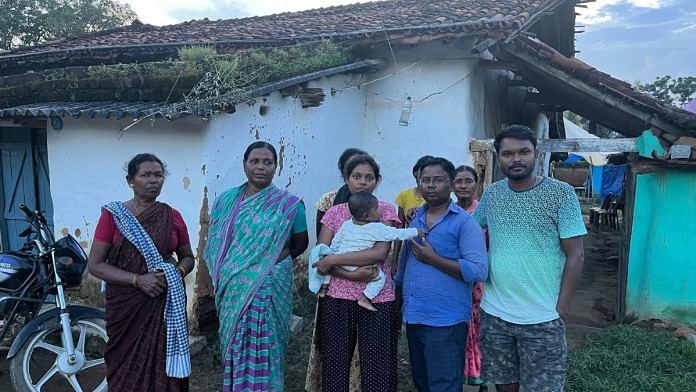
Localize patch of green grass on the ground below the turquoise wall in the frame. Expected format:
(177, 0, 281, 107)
(566, 325, 696, 392)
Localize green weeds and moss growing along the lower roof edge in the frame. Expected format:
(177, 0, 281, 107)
(0, 41, 349, 115)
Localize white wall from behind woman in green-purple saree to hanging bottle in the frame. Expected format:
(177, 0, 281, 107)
(198, 40, 486, 236)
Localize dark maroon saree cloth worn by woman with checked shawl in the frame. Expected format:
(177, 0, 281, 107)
(104, 203, 189, 392)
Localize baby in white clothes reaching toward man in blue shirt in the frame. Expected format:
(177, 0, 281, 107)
(309, 192, 419, 311)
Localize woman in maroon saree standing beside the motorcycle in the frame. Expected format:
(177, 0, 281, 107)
(89, 154, 194, 392)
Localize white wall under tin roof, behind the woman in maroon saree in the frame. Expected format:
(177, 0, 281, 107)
(47, 117, 207, 306)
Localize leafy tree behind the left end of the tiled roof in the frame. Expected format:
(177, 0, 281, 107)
(0, 0, 137, 50)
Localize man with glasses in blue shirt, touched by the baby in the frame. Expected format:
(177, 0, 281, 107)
(395, 158, 488, 392)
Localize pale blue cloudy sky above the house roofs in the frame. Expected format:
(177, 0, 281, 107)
(119, 0, 696, 83)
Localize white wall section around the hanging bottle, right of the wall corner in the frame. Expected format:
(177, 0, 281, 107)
(363, 39, 486, 202)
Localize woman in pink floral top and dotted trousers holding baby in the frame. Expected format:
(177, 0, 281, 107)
(309, 155, 401, 392)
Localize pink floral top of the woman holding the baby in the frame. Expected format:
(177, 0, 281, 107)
(321, 201, 401, 303)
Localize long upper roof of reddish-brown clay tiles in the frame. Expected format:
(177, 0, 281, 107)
(0, 0, 574, 60)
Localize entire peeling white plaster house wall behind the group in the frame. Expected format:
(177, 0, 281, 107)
(43, 41, 485, 314)
